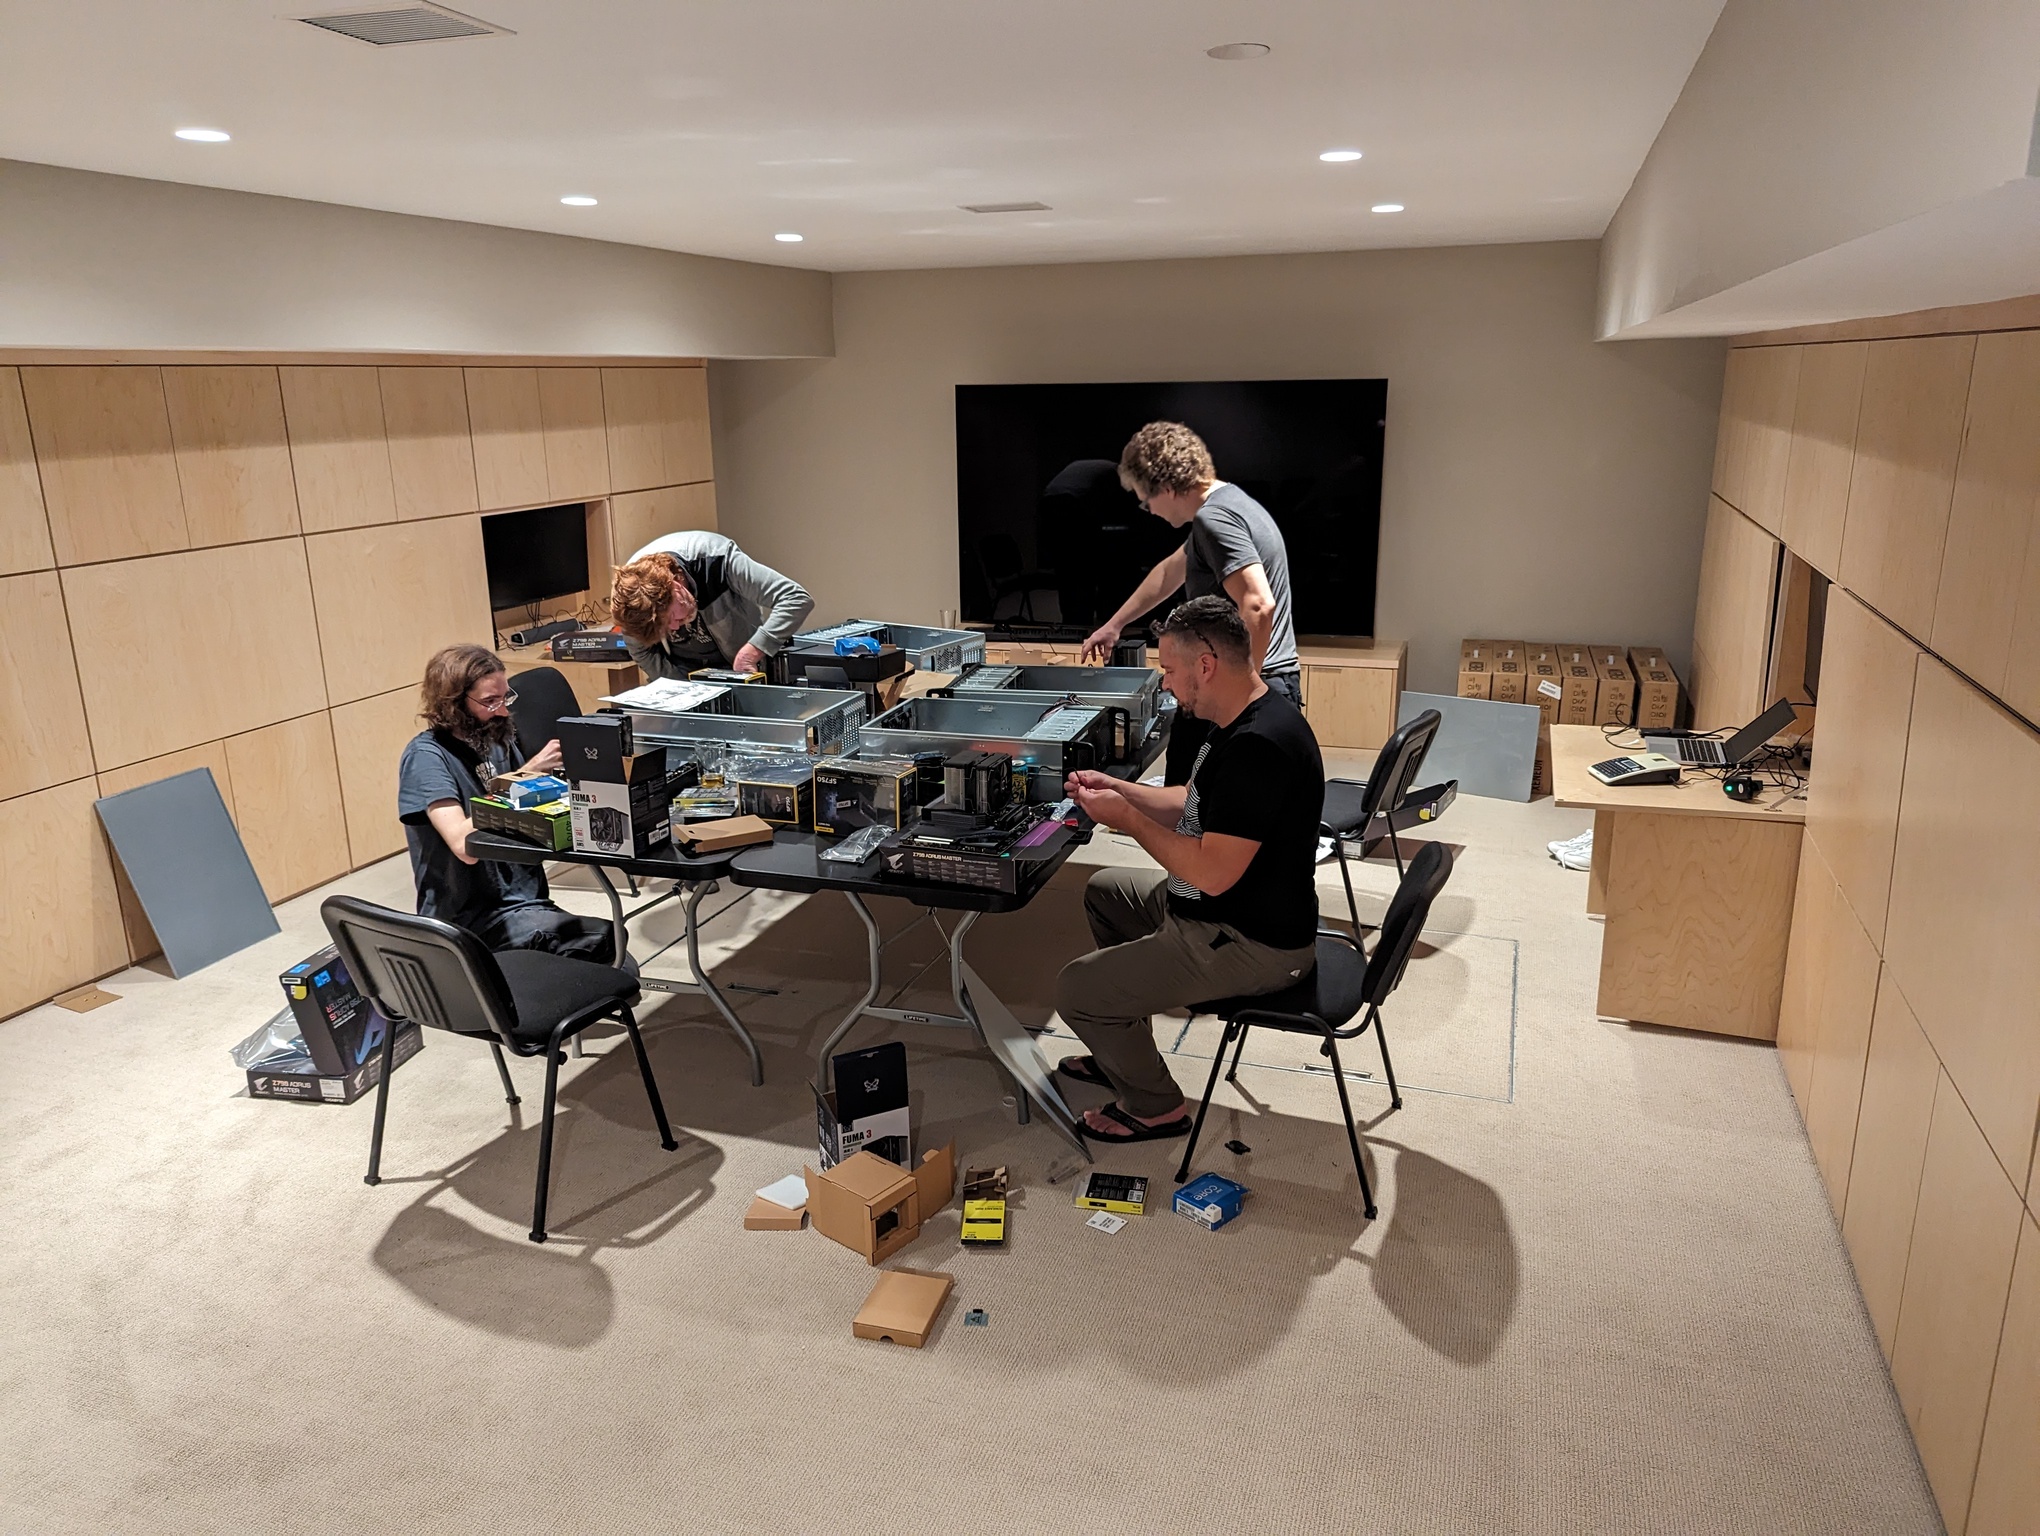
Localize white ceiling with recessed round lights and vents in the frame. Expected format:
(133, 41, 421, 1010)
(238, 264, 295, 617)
(0, 0, 1722, 271)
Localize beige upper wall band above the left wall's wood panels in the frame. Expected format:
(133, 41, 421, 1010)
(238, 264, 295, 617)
(0, 161, 830, 357)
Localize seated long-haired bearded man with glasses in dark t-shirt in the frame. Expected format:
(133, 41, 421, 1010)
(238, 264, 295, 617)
(396, 645, 616, 965)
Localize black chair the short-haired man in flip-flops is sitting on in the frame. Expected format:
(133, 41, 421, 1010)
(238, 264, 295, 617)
(1175, 842, 1452, 1220)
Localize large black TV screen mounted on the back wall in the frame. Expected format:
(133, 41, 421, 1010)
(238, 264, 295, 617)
(957, 379, 1389, 636)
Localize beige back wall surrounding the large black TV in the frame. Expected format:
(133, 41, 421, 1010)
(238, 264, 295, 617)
(710, 243, 1724, 692)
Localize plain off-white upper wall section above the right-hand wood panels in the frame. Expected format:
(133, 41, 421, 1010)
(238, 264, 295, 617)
(1597, 0, 2040, 335)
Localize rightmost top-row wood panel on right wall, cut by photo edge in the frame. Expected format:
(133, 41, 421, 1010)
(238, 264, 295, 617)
(1932, 330, 2040, 696)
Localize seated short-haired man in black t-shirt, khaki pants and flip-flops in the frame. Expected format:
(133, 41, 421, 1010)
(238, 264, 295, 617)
(1057, 596, 1324, 1142)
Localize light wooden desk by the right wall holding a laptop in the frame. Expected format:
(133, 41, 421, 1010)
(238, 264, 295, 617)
(1550, 726, 1805, 1040)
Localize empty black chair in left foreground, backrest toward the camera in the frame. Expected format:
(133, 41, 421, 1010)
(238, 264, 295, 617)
(318, 895, 679, 1242)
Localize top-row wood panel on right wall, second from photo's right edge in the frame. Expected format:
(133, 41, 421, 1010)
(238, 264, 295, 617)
(1840, 337, 1977, 636)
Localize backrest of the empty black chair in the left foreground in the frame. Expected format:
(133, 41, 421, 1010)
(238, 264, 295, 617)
(318, 895, 516, 1048)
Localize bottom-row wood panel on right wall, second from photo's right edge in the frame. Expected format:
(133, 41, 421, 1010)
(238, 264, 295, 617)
(1891, 1075, 2026, 1532)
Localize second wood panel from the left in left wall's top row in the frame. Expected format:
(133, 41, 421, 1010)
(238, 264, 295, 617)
(20, 367, 190, 565)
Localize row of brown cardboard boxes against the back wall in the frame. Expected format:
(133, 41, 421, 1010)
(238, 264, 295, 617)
(1459, 641, 1679, 796)
